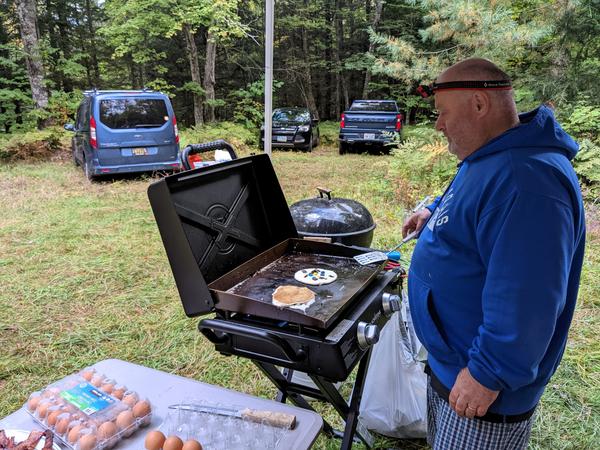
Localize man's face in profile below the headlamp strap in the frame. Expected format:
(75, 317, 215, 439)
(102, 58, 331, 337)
(435, 90, 481, 161)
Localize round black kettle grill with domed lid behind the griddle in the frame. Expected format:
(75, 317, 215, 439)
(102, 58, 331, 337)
(290, 188, 375, 247)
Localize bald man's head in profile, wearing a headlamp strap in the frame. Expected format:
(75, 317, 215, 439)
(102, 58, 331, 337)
(435, 58, 519, 160)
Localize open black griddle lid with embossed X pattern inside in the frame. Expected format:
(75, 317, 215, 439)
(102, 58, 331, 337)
(148, 154, 298, 317)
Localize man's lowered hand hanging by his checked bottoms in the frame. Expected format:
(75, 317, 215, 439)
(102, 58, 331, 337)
(448, 367, 499, 419)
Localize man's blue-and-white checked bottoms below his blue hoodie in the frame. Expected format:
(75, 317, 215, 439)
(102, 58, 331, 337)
(427, 382, 535, 450)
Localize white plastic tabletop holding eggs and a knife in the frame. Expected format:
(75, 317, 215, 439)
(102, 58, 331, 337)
(0, 359, 323, 450)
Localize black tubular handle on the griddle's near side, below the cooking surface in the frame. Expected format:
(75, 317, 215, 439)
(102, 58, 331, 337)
(198, 319, 306, 362)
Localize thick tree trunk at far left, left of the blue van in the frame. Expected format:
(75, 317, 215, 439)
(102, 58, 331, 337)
(17, 0, 48, 129)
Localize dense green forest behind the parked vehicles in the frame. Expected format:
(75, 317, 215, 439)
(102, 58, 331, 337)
(0, 0, 600, 156)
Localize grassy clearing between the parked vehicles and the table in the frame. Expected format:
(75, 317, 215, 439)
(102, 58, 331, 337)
(0, 141, 600, 450)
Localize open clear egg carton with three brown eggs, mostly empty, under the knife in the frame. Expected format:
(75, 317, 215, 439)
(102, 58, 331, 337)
(144, 401, 289, 450)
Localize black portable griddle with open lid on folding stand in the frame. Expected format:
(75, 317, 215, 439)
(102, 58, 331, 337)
(148, 154, 401, 449)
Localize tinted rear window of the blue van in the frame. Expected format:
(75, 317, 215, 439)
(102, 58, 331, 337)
(100, 98, 169, 129)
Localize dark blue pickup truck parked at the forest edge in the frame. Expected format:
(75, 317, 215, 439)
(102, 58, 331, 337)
(339, 100, 402, 155)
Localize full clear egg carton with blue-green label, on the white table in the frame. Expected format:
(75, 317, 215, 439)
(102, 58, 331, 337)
(24, 368, 152, 450)
